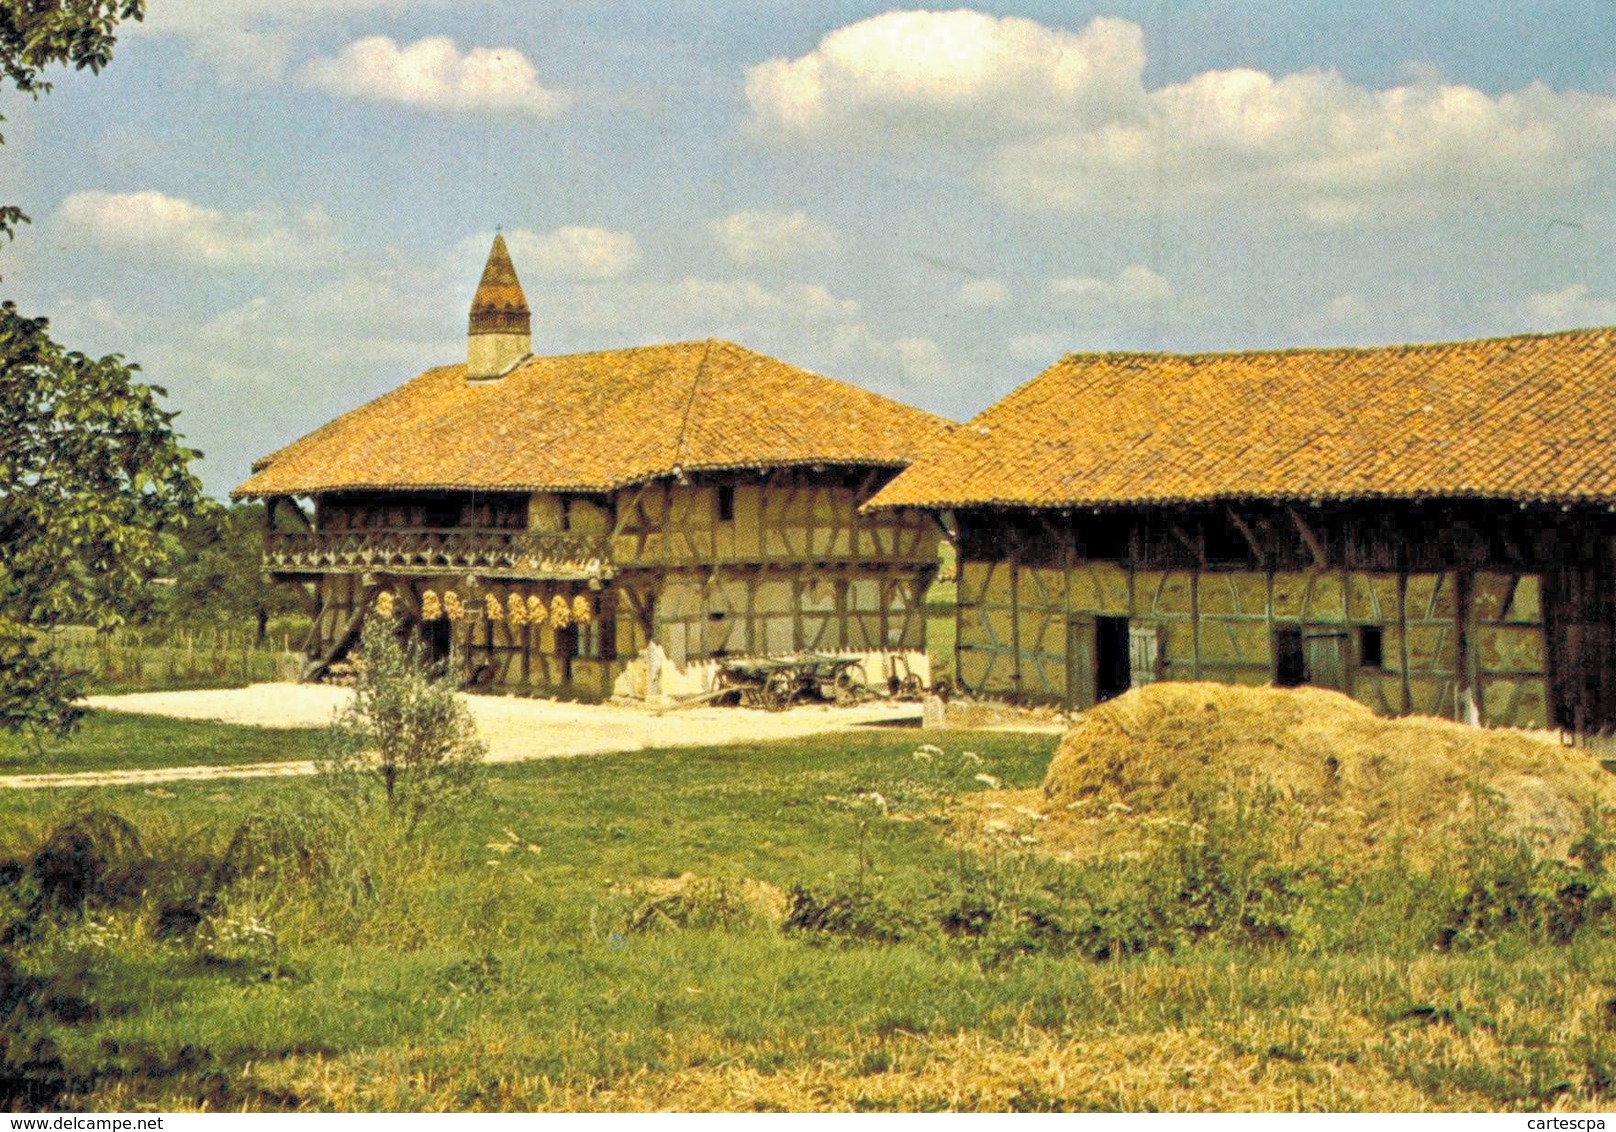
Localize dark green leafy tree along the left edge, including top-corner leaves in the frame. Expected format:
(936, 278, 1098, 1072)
(0, 0, 199, 734)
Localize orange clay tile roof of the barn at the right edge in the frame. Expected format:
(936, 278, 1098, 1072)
(871, 328, 1616, 508)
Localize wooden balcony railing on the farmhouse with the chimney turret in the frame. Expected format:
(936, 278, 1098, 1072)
(263, 529, 616, 579)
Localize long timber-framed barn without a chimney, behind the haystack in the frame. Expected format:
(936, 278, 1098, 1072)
(871, 330, 1616, 734)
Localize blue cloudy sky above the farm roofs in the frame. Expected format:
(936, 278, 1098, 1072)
(0, 0, 1616, 495)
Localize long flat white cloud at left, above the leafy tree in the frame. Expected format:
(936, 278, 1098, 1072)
(52, 189, 338, 268)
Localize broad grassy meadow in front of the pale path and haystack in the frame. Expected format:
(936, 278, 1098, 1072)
(0, 721, 1616, 1109)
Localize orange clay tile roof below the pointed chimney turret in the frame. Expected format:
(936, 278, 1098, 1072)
(231, 341, 950, 498)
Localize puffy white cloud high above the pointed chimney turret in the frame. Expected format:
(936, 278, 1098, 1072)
(299, 36, 570, 118)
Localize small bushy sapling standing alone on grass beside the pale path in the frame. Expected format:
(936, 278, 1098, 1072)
(320, 613, 488, 831)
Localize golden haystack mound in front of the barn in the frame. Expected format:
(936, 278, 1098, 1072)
(1044, 682, 1616, 860)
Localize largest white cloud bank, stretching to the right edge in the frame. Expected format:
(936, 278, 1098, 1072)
(747, 11, 1616, 225)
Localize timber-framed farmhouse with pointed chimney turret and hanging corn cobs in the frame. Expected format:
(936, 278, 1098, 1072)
(233, 236, 949, 699)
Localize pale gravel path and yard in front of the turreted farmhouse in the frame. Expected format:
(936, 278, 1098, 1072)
(0, 684, 920, 789)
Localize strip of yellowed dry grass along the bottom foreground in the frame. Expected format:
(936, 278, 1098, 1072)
(189, 957, 1616, 1111)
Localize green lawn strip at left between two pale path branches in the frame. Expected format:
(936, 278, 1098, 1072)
(0, 712, 322, 775)
